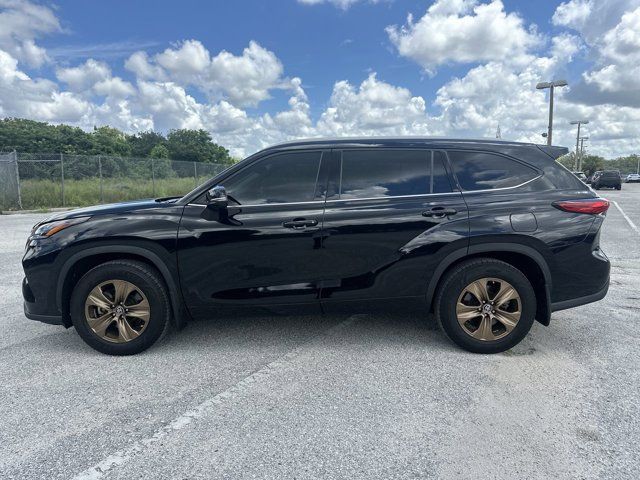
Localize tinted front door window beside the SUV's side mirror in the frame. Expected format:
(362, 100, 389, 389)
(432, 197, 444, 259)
(224, 152, 321, 205)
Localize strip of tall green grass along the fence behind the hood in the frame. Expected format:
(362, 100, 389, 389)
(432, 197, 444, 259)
(12, 177, 205, 210)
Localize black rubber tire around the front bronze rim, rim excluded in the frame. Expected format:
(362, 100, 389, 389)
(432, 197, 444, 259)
(70, 260, 171, 355)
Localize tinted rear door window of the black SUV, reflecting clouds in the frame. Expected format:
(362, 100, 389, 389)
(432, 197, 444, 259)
(340, 150, 451, 199)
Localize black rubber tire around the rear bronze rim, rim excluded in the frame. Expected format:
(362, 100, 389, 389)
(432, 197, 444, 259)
(435, 258, 536, 353)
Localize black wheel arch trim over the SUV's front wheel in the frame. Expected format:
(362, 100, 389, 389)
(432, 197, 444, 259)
(56, 245, 188, 328)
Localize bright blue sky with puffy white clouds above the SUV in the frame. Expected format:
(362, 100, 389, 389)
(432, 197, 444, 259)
(0, 0, 640, 157)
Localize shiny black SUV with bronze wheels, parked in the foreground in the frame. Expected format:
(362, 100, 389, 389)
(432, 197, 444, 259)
(22, 138, 609, 355)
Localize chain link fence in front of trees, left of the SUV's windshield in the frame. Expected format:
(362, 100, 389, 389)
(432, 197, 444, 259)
(0, 152, 226, 210)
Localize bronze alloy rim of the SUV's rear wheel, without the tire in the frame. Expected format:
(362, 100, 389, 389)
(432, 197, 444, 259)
(456, 278, 522, 341)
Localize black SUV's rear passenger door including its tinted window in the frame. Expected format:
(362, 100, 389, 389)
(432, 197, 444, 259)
(318, 147, 468, 310)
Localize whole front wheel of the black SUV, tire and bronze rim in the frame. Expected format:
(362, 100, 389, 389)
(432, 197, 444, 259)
(70, 260, 171, 355)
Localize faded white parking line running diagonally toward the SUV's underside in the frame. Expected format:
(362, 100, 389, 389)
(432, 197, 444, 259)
(74, 315, 358, 480)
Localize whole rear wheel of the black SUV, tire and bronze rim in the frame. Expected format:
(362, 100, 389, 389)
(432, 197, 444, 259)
(435, 258, 536, 353)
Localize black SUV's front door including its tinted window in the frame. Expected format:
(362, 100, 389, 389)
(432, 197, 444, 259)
(178, 150, 329, 317)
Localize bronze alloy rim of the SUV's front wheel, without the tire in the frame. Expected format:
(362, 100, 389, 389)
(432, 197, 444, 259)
(84, 280, 151, 343)
